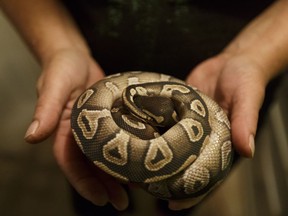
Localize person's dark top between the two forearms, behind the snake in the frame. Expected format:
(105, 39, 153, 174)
(62, 0, 272, 79)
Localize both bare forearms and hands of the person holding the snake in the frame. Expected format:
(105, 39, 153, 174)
(0, 0, 288, 210)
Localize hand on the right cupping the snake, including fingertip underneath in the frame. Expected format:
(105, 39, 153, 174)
(169, 54, 268, 210)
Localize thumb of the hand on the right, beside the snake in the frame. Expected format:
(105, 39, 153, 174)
(230, 82, 264, 158)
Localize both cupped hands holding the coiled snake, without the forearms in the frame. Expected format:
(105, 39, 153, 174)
(25, 49, 267, 210)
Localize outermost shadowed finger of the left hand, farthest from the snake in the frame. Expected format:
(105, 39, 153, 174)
(54, 126, 108, 206)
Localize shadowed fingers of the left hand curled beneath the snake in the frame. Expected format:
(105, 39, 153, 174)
(54, 125, 129, 210)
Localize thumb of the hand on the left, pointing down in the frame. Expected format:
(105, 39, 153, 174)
(24, 72, 70, 143)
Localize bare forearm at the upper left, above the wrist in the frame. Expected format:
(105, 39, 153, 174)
(0, 0, 89, 63)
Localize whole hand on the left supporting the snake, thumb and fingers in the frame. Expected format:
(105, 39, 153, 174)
(25, 49, 128, 210)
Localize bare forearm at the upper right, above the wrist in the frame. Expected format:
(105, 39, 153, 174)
(225, 0, 288, 82)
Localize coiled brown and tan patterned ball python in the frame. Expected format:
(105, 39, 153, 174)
(71, 71, 234, 203)
